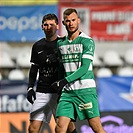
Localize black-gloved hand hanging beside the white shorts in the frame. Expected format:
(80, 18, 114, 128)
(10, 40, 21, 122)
(27, 88, 36, 104)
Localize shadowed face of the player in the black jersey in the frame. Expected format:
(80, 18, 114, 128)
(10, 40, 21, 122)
(42, 20, 59, 37)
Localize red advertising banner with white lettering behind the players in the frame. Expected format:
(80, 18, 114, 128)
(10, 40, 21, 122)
(59, 3, 133, 41)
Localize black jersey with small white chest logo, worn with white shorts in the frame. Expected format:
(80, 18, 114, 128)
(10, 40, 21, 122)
(29, 38, 59, 93)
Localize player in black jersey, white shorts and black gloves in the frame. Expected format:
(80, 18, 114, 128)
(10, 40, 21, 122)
(27, 14, 77, 133)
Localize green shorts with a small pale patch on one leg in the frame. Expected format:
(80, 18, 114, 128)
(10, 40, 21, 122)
(56, 94, 100, 121)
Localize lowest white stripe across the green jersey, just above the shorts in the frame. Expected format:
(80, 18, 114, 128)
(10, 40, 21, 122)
(63, 79, 96, 90)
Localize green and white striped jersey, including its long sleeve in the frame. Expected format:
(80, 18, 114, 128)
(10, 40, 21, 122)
(58, 32, 96, 95)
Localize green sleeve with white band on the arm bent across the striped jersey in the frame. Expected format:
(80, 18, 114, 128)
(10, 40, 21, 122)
(66, 39, 95, 82)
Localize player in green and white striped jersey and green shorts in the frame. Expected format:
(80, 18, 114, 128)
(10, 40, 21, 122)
(50, 8, 106, 133)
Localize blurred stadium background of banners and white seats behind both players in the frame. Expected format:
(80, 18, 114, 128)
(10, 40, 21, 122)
(0, 0, 133, 133)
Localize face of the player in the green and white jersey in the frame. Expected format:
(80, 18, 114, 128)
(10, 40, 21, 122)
(63, 12, 80, 33)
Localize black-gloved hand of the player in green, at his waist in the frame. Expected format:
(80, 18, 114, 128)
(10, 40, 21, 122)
(50, 78, 68, 93)
